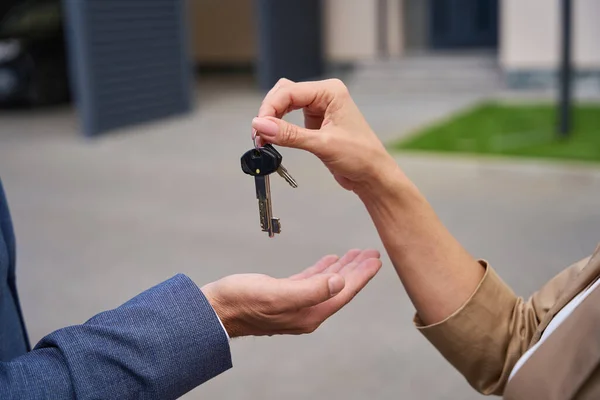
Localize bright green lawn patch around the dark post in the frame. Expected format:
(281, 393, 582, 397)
(393, 103, 600, 162)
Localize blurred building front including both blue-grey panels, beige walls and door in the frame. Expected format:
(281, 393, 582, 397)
(60, 0, 600, 135)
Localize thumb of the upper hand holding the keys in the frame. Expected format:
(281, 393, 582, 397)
(252, 117, 322, 152)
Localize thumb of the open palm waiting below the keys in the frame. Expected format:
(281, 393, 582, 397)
(279, 274, 346, 311)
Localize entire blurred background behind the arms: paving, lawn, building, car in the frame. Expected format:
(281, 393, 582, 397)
(0, 0, 600, 399)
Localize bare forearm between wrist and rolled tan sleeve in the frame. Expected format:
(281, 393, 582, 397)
(357, 162, 485, 324)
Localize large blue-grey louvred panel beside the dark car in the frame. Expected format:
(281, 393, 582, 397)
(64, 0, 192, 135)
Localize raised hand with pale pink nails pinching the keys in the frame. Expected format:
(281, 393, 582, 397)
(252, 79, 400, 193)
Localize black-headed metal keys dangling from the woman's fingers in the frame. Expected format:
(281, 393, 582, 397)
(241, 144, 298, 237)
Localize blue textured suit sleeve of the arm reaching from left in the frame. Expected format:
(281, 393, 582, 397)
(0, 275, 232, 399)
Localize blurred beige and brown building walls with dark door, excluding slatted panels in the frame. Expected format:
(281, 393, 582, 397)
(190, 0, 600, 88)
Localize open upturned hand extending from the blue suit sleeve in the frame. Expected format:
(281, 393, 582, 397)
(202, 250, 381, 338)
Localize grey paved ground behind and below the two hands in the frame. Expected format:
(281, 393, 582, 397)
(0, 57, 600, 400)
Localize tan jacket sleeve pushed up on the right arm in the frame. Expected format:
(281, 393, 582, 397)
(414, 260, 585, 395)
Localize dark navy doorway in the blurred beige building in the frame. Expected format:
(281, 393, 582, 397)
(429, 0, 498, 49)
